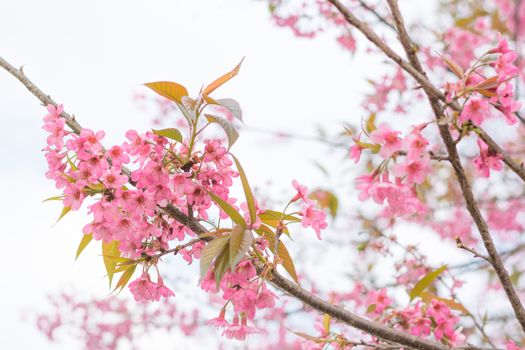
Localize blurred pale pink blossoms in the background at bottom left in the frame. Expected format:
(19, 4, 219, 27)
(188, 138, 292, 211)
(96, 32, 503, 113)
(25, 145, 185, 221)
(36, 293, 202, 350)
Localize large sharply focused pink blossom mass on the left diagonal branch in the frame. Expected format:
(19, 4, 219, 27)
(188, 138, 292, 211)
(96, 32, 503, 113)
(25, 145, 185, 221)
(44, 98, 327, 339)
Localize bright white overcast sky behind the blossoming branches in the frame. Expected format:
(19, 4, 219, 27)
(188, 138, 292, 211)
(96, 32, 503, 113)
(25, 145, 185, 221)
(0, 0, 478, 350)
